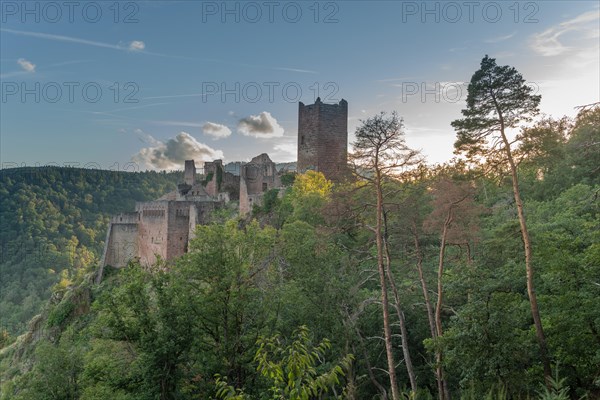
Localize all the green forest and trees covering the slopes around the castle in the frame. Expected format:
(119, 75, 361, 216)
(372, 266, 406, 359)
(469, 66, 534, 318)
(0, 57, 600, 400)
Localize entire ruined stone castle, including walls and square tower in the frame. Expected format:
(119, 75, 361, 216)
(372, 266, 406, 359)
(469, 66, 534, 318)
(98, 98, 348, 281)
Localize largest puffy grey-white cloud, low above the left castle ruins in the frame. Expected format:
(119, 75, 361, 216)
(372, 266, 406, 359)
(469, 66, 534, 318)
(132, 130, 223, 171)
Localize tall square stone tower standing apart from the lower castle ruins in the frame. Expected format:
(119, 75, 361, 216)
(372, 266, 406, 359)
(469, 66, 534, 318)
(298, 97, 348, 180)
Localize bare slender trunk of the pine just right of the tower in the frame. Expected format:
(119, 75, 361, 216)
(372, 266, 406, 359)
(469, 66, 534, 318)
(375, 167, 400, 400)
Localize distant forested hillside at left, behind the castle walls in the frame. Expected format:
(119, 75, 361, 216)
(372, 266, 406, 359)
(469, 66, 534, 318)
(0, 167, 181, 335)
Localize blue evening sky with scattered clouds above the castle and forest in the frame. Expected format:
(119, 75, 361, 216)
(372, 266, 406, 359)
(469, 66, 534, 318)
(0, 0, 600, 171)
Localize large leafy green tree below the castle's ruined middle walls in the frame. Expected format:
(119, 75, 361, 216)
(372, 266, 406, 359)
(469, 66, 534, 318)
(178, 220, 279, 387)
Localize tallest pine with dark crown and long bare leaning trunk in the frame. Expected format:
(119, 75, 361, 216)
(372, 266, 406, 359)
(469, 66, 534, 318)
(452, 55, 552, 382)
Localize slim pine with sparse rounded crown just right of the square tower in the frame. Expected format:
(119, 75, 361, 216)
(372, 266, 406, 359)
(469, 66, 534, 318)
(352, 112, 418, 400)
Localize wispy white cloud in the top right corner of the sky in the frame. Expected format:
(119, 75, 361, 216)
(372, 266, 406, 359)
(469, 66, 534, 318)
(530, 10, 600, 57)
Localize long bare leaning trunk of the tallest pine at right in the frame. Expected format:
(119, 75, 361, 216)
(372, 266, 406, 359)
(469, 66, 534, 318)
(498, 120, 552, 385)
